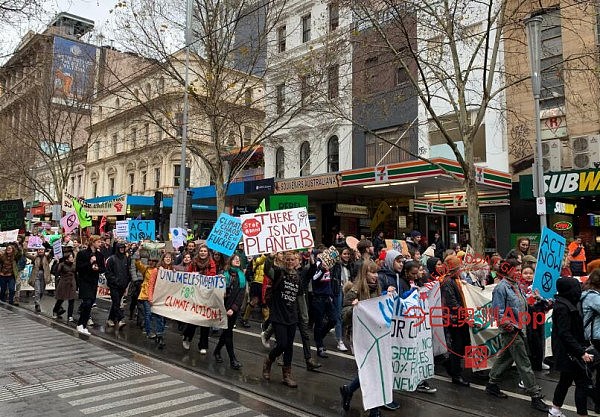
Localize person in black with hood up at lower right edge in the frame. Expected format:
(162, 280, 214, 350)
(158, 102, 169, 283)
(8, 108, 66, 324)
(548, 278, 593, 417)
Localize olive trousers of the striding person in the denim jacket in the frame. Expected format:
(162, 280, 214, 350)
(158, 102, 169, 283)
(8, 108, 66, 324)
(490, 331, 541, 397)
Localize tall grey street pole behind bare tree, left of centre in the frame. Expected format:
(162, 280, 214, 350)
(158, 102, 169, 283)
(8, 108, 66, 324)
(171, 0, 192, 228)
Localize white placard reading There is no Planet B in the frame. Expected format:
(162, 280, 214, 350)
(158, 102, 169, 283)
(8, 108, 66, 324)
(240, 207, 314, 256)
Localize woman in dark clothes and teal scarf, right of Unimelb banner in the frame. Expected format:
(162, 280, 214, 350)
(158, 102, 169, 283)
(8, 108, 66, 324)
(213, 254, 246, 370)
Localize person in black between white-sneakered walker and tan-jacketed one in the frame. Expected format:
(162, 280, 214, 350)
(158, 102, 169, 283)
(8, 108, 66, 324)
(105, 242, 131, 329)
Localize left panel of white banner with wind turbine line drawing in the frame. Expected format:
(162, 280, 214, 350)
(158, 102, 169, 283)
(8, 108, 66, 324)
(352, 296, 394, 410)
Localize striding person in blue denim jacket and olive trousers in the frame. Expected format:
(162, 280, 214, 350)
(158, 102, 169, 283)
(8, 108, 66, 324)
(485, 259, 548, 412)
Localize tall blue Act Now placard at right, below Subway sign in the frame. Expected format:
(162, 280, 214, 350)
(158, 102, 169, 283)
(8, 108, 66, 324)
(533, 227, 567, 298)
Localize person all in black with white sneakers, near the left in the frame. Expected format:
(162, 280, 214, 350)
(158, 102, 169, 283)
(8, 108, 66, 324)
(75, 235, 104, 335)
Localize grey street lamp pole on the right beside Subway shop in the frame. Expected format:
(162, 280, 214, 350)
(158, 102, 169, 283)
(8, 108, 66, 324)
(525, 16, 547, 229)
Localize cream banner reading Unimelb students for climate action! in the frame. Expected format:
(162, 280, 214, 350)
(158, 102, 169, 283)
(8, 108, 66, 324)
(152, 268, 227, 329)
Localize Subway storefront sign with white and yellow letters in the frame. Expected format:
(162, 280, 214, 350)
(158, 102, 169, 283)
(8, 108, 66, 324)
(519, 168, 600, 198)
